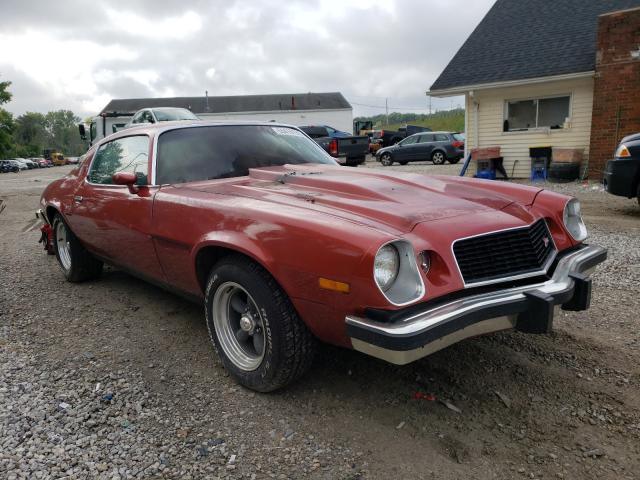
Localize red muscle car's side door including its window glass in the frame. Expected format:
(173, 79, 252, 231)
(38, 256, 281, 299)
(68, 135, 164, 281)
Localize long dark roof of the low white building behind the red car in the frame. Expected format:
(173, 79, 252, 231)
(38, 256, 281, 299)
(101, 92, 351, 114)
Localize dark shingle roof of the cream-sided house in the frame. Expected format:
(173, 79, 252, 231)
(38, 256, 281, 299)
(431, 0, 640, 91)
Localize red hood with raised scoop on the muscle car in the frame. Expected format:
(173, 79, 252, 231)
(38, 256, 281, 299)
(176, 165, 540, 233)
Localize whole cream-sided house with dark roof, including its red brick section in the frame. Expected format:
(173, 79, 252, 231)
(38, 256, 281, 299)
(427, 0, 640, 180)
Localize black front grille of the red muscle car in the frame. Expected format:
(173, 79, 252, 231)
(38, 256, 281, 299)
(453, 219, 555, 284)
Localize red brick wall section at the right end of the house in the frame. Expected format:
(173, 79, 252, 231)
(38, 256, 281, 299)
(589, 8, 640, 179)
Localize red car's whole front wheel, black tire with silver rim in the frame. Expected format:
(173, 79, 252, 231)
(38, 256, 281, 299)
(205, 255, 316, 392)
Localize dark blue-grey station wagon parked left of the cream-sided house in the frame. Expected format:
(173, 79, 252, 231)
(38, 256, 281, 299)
(376, 132, 464, 167)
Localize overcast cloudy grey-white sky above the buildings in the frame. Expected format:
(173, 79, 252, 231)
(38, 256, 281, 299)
(0, 0, 494, 117)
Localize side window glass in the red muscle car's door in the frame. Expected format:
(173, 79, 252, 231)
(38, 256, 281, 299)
(87, 135, 149, 185)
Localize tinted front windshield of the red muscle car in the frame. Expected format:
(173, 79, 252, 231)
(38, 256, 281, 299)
(156, 125, 337, 185)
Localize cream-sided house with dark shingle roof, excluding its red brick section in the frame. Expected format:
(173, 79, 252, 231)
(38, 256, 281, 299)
(427, 0, 640, 178)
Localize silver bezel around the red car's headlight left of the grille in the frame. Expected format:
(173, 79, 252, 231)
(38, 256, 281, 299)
(372, 240, 425, 306)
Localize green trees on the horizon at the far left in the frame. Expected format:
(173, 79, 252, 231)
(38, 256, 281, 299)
(0, 81, 87, 159)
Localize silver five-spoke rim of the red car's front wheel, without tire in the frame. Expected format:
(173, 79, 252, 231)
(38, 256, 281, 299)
(211, 282, 266, 372)
